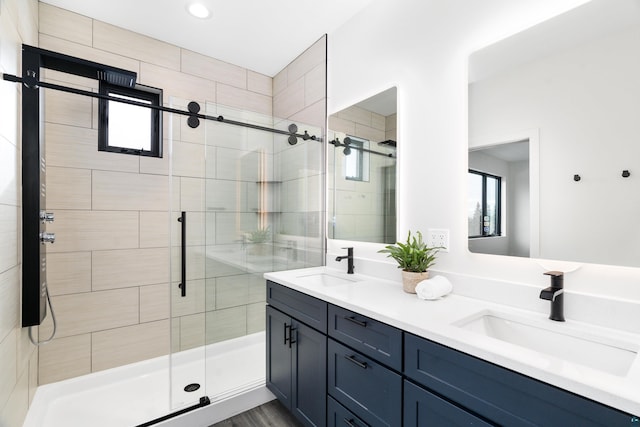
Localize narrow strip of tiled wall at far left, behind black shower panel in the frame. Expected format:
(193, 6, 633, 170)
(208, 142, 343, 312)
(0, 0, 38, 427)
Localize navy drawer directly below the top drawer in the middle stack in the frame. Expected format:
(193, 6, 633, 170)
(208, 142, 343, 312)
(327, 339, 402, 427)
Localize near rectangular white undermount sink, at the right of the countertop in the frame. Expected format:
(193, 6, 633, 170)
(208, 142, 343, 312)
(453, 310, 640, 376)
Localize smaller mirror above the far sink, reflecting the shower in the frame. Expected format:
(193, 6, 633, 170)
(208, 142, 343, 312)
(327, 87, 398, 243)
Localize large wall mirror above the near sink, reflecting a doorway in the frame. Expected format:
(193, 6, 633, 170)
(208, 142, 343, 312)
(468, 0, 640, 266)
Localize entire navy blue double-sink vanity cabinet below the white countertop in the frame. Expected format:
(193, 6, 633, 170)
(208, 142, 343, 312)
(267, 281, 637, 427)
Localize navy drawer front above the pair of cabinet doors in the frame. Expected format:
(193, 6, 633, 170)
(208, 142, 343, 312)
(267, 280, 327, 334)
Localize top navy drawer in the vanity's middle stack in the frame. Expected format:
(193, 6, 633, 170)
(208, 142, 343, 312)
(328, 304, 402, 372)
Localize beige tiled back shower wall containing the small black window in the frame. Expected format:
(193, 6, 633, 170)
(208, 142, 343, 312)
(34, 3, 273, 384)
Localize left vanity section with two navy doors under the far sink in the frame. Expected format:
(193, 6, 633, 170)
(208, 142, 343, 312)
(266, 283, 327, 427)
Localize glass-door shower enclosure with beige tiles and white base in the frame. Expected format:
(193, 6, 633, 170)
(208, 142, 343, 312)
(15, 38, 326, 426)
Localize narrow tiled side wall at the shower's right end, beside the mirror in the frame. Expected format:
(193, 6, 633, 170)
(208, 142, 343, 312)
(273, 36, 327, 266)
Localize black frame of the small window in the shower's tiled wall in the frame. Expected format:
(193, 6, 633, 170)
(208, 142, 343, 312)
(98, 81, 162, 158)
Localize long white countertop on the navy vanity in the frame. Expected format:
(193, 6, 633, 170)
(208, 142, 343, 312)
(264, 267, 640, 415)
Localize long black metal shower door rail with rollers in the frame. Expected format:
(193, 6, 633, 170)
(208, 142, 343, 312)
(2, 73, 322, 145)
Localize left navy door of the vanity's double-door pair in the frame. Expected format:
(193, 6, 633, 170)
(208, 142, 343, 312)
(266, 306, 292, 409)
